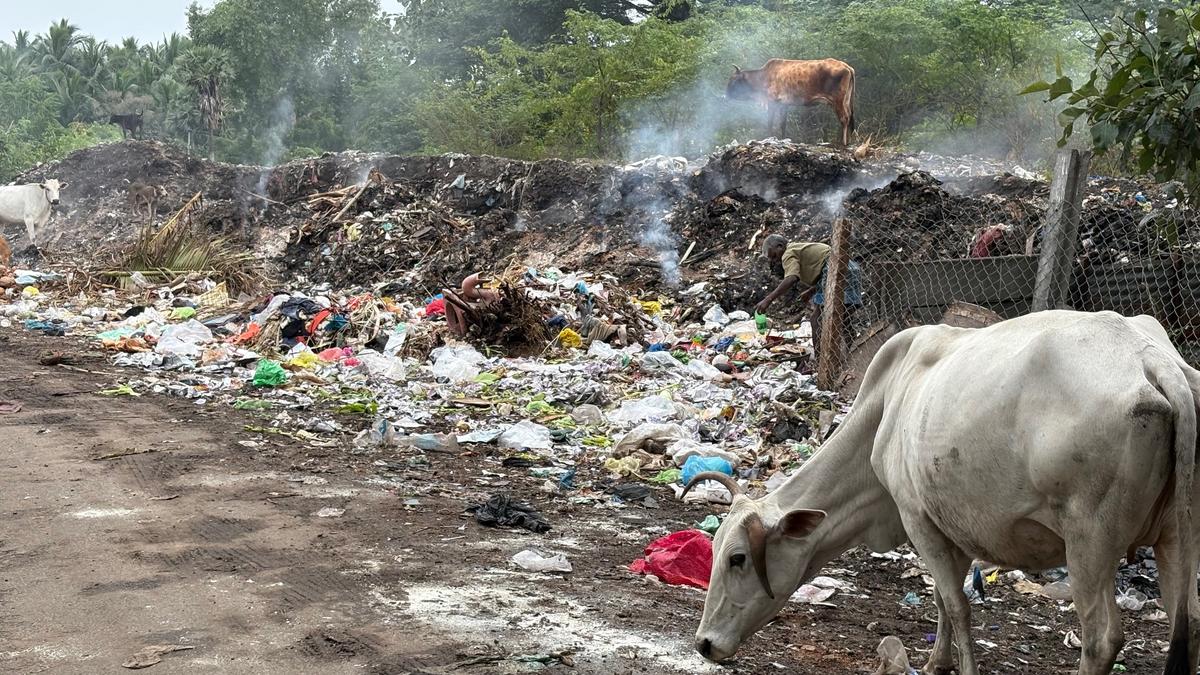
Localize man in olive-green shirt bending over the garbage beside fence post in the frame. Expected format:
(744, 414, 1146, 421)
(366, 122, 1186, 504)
(754, 234, 863, 365)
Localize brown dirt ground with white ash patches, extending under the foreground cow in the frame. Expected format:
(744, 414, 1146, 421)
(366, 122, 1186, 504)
(0, 335, 1166, 675)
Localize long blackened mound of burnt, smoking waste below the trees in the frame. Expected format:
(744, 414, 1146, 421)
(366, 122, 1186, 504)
(5, 141, 1195, 311)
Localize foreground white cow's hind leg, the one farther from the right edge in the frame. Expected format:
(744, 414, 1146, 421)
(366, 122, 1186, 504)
(1067, 530, 1124, 675)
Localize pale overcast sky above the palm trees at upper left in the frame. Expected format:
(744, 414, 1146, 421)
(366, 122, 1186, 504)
(0, 0, 400, 43)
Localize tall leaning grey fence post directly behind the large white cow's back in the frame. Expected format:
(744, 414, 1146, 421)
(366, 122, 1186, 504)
(1033, 150, 1092, 312)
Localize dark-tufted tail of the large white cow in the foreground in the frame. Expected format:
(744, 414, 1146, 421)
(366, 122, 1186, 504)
(1153, 363, 1196, 675)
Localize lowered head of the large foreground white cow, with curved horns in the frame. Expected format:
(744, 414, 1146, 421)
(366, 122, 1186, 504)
(688, 472, 826, 661)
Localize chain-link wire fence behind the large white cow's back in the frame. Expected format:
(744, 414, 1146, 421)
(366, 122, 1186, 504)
(842, 162, 1200, 390)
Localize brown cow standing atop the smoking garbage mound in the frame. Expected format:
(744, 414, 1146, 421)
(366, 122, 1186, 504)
(725, 59, 854, 145)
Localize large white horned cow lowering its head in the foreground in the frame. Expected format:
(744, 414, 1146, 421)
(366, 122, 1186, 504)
(692, 311, 1200, 675)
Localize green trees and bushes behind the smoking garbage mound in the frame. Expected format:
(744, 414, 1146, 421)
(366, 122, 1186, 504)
(0, 0, 1172, 181)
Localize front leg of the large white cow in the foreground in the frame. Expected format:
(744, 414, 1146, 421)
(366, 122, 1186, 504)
(902, 515, 979, 675)
